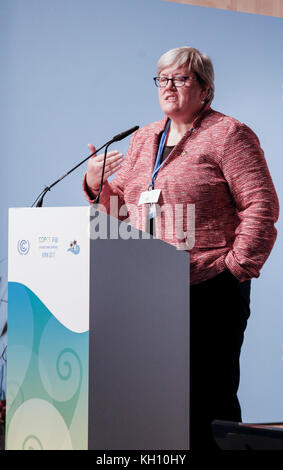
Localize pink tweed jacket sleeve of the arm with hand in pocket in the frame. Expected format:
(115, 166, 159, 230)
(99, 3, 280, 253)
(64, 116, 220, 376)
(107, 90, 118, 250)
(221, 123, 279, 281)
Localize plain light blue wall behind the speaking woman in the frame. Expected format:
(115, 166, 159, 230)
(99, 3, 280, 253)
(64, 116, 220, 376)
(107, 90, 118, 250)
(0, 0, 283, 421)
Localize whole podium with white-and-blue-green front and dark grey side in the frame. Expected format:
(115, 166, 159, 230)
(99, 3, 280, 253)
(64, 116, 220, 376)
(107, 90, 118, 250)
(6, 207, 189, 450)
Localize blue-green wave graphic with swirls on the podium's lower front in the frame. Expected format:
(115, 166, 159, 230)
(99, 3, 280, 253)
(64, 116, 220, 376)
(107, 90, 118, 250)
(6, 283, 89, 450)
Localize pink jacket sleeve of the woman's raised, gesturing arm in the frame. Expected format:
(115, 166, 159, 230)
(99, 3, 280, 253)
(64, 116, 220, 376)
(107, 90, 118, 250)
(83, 129, 136, 220)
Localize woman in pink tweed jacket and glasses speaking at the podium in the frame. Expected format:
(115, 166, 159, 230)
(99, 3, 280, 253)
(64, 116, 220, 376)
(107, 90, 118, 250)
(83, 47, 279, 450)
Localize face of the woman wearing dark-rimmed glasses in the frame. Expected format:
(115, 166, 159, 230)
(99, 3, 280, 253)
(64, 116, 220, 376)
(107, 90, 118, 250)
(158, 65, 207, 123)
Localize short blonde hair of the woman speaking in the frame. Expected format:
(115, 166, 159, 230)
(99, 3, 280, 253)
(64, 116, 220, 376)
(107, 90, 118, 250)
(157, 46, 214, 104)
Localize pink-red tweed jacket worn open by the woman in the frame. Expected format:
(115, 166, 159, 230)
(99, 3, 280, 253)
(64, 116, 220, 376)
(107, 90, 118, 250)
(83, 107, 279, 284)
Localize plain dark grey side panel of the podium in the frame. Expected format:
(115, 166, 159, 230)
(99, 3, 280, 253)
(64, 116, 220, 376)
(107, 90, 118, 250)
(89, 211, 189, 450)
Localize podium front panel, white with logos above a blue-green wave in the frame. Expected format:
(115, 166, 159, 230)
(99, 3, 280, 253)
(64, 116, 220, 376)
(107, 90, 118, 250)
(6, 207, 89, 450)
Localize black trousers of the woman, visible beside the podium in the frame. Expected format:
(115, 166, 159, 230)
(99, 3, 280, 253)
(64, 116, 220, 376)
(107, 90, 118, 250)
(190, 269, 251, 450)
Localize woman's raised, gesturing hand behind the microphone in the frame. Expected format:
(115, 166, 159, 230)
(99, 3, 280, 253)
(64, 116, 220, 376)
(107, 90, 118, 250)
(86, 144, 123, 193)
